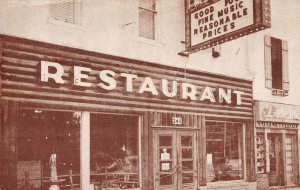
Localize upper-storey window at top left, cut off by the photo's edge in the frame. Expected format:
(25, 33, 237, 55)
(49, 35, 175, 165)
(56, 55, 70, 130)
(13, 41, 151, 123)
(50, 0, 79, 24)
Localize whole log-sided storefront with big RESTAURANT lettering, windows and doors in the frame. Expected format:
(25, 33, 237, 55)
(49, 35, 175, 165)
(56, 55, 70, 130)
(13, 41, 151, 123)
(0, 36, 255, 190)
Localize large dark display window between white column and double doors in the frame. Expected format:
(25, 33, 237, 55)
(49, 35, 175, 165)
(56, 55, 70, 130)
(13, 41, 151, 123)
(91, 114, 139, 189)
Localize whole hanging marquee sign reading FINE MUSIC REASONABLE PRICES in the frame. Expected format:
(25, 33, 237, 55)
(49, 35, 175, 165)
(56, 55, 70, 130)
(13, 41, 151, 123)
(179, 0, 271, 55)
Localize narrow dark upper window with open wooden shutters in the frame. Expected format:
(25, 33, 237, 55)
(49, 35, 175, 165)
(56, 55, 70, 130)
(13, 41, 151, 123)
(265, 36, 289, 95)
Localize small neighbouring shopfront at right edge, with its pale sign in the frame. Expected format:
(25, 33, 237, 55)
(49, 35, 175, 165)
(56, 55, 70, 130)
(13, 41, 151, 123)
(255, 101, 300, 189)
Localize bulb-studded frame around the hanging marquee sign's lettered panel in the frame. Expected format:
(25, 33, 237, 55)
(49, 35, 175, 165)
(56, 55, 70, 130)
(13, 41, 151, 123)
(178, 0, 271, 56)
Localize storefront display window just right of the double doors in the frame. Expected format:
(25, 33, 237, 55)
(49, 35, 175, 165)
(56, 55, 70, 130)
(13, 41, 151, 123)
(206, 121, 243, 182)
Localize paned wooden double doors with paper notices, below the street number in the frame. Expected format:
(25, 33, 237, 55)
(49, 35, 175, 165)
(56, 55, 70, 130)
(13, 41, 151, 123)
(153, 129, 197, 190)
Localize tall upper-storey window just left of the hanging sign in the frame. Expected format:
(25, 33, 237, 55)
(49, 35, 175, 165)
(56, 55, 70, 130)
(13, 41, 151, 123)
(139, 0, 157, 40)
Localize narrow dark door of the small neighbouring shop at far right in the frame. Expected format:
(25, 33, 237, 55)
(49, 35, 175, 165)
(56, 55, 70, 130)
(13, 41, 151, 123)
(268, 133, 284, 186)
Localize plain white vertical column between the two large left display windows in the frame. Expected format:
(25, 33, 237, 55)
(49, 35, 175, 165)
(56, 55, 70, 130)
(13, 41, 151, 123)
(80, 111, 90, 190)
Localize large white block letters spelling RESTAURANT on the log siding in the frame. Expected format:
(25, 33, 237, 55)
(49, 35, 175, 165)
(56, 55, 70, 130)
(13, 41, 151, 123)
(40, 61, 244, 105)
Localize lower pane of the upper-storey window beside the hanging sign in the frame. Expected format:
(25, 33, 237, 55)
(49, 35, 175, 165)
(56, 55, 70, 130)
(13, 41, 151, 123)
(139, 8, 155, 39)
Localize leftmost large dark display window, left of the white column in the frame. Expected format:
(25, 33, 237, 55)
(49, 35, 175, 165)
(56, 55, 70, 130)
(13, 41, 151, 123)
(17, 109, 80, 189)
